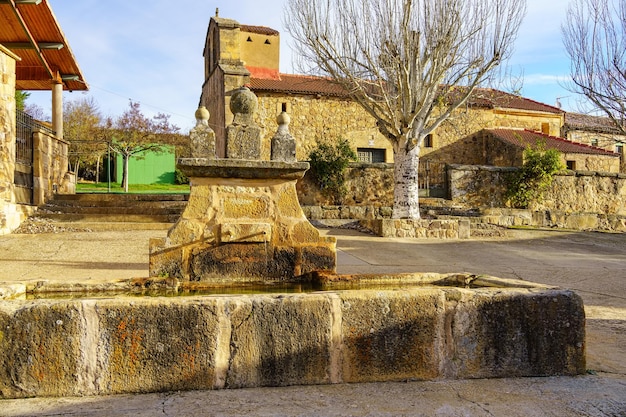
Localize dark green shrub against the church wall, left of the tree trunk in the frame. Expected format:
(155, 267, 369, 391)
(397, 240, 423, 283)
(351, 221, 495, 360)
(309, 139, 357, 204)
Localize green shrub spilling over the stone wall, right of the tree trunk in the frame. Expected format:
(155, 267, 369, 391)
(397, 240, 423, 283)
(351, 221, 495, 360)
(505, 143, 565, 208)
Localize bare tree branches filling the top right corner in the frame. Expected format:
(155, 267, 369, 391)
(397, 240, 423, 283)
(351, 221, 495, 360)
(561, 0, 626, 135)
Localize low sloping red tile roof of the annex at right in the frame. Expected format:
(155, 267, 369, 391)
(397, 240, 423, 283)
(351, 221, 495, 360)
(485, 129, 619, 157)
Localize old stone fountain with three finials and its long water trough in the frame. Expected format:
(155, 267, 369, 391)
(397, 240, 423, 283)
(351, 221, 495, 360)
(0, 90, 585, 398)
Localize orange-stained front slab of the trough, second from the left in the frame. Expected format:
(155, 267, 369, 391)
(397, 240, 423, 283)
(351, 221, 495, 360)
(91, 299, 224, 394)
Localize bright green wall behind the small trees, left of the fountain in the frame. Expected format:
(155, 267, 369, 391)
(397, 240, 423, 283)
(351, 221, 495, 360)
(116, 147, 176, 184)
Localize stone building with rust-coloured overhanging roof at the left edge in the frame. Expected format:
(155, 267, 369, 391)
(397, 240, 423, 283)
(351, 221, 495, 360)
(0, 1, 87, 234)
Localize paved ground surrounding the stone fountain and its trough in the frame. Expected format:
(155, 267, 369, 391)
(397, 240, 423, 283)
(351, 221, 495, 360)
(0, 229, 626, 417)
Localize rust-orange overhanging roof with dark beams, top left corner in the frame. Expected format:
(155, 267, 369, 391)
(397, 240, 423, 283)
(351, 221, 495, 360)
(0, 0, 89, 91)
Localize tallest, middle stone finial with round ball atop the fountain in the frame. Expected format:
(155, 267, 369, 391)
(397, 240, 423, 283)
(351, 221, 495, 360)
(226, 87, 261, 160)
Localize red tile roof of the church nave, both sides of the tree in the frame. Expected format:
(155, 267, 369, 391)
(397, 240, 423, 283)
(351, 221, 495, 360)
(250, 74, 563, 114)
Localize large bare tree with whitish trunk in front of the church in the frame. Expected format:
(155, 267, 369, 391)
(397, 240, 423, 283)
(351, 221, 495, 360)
(285, 0, 526, 219)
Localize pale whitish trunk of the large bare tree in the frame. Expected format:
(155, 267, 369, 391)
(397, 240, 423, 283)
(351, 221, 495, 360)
(392, 146, 420, 219)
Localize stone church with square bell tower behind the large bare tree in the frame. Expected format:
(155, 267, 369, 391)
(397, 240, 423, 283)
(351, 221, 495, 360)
(200, 17, 615, 179)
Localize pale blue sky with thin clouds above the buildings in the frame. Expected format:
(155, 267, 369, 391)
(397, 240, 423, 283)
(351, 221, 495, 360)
(29, 0, 578, 131)
